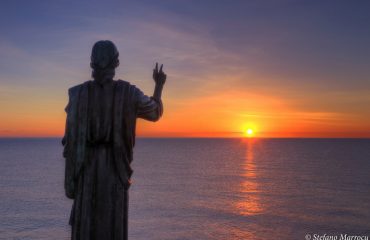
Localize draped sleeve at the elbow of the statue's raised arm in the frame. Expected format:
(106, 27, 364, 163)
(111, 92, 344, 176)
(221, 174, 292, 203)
(135, 87, 163, 122)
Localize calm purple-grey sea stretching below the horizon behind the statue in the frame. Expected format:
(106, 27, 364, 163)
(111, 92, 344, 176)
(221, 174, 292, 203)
(0, 139, 370, 240)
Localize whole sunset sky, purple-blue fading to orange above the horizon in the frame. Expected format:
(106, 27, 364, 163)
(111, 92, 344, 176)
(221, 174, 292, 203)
(0, 0, 370, 137)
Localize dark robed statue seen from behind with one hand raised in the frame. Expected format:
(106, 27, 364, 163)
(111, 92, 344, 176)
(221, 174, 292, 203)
(62, 41, 166, 240)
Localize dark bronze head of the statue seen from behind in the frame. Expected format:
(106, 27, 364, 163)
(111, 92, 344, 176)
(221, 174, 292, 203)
(90, 40, 119, 81)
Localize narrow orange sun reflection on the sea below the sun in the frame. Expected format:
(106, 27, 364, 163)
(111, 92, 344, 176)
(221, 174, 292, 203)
(235, 139, 263, 216)
